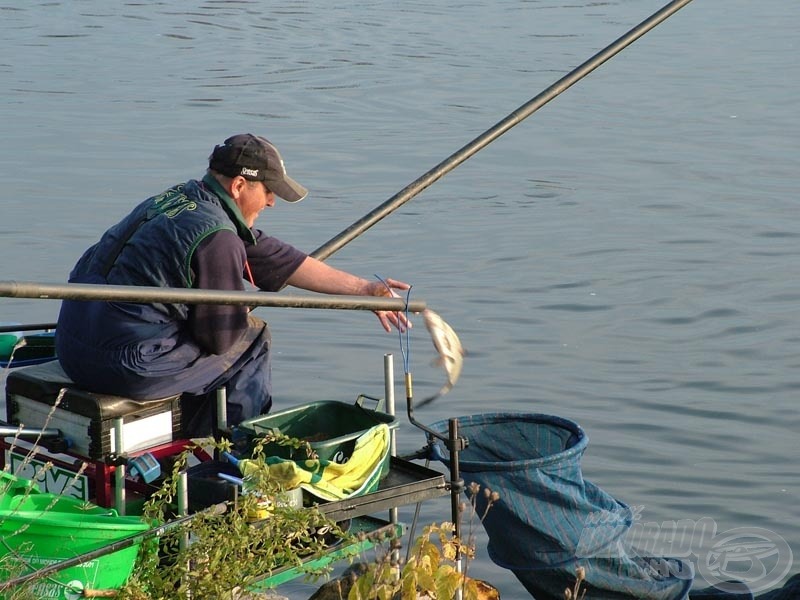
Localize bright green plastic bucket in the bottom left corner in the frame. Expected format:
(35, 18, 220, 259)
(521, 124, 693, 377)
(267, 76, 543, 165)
(0, 473, 149, 600)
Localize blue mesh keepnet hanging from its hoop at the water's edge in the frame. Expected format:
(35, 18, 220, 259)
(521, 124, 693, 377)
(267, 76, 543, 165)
(430, 413, 694, 600)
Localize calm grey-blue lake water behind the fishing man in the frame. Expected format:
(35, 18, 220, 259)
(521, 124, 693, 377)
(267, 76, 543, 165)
(0, 0, 800, 600)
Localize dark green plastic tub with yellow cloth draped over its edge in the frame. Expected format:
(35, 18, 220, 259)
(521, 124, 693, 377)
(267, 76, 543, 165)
(238, 396, 398, 464)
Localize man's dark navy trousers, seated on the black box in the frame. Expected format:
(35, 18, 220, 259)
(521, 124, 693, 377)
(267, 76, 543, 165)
(56, 301, 272, 437)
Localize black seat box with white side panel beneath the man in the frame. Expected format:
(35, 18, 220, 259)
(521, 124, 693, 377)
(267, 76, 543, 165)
(6, 361, 181, 460)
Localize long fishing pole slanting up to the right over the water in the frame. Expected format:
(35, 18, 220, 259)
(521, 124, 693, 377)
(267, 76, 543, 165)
(311, 0, 692, 260)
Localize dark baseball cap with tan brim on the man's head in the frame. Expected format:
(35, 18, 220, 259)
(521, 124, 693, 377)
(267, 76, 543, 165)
(208, 133, 308, 202)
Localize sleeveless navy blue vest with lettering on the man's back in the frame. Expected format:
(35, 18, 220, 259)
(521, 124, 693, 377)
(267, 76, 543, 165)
(69, 176, 252, 320)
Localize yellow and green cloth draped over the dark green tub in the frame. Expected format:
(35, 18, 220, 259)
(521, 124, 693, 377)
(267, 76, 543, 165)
(239, 423, 389, 501)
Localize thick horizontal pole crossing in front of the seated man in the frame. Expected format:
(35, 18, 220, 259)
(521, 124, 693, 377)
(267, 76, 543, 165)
(0, 281, 426, 312)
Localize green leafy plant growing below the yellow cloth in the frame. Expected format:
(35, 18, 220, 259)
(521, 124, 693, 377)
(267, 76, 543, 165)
(121, 440, 347, 600)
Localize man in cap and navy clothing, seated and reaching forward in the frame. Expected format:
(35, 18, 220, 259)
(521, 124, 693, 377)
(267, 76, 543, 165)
(56, 134, 410, 436)
